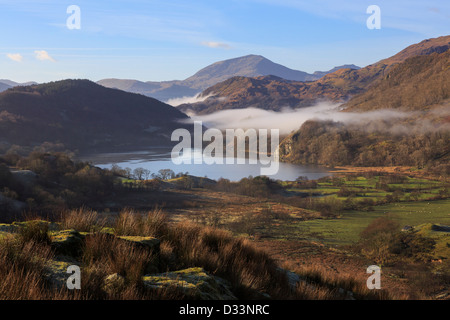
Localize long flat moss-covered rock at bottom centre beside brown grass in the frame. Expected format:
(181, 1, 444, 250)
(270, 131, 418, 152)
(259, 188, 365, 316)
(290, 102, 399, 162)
(142, 268, 237, 300)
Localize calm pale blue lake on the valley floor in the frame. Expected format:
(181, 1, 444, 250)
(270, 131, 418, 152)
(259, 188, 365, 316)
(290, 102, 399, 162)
(79, 147, 329, 181)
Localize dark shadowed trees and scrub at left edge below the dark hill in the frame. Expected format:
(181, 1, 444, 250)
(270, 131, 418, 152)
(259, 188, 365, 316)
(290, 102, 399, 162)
(0, 151, 115, 218)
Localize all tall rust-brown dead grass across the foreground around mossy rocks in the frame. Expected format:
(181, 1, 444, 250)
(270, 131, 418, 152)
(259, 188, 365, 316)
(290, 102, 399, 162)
(0, 209, 412, 300)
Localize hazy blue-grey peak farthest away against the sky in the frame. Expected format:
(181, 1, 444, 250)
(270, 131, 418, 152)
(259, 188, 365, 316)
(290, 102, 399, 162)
(97, 55, 359, 101)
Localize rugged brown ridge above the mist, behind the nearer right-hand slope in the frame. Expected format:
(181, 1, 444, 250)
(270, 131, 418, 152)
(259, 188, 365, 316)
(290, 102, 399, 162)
(179, 36, 450, 114)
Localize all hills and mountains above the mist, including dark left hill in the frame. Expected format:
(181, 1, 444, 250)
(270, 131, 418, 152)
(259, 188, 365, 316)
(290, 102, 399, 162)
(0, 36, 450, 158)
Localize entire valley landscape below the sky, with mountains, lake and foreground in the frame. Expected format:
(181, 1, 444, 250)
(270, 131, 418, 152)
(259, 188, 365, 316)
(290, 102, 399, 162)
(0, 36, 450, 300)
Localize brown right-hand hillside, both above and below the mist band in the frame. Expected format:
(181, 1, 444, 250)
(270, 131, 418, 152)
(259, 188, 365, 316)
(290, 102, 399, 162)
(280, 44, 450, 170)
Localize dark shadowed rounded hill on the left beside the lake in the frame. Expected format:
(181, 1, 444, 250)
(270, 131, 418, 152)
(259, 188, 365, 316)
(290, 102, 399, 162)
(0, 80, 188, 152)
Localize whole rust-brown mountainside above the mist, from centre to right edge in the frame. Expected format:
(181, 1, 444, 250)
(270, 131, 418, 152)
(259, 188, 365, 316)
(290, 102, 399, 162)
(178, 36, 450, 114)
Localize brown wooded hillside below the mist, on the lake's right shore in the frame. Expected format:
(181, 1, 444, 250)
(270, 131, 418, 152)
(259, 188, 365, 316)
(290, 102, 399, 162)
(280, 120, 450, 175)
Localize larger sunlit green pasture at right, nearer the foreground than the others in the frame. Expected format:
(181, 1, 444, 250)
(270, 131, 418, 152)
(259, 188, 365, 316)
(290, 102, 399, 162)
(289, 200, 450, 245)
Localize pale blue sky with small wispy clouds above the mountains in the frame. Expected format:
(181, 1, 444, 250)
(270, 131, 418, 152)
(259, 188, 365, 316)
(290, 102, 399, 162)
(0, 0, 450, 82)
